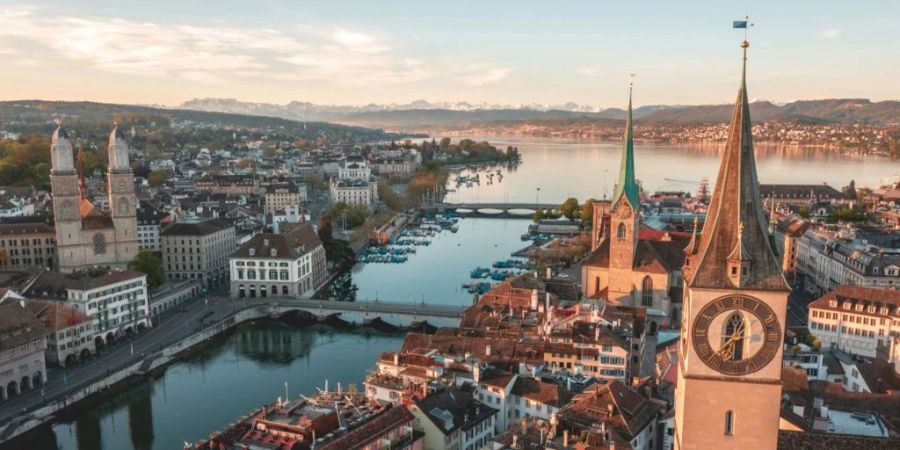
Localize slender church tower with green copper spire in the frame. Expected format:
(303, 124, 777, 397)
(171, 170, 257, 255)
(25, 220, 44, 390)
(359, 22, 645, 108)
(609, 87, 641, 300)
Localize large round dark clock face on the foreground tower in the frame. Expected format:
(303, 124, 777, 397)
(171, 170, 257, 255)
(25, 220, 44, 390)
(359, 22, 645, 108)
(691, 295, 783, 375)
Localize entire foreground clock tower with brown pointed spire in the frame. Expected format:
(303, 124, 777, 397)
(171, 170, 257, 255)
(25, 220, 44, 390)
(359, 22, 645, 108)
(675, 41, 790, 450)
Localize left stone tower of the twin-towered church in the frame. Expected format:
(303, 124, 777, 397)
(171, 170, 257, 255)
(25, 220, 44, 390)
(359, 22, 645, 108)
(50, 124, 84, 269)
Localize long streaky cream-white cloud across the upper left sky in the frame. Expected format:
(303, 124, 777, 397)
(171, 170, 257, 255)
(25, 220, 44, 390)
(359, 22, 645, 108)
(0, 9, 444, 85)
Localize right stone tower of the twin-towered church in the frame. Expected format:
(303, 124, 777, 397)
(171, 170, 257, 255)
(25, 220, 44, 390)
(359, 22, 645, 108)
(107, 124, 138, 263)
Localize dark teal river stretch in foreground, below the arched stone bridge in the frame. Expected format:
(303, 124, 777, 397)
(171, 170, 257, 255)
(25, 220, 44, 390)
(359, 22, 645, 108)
(8, 321, 402, 450)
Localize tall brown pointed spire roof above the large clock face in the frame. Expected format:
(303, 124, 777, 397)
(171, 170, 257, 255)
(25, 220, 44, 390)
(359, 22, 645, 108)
(686, 42, 788, 290)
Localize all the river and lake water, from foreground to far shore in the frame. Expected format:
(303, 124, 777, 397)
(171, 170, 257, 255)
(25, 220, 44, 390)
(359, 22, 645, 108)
(15, 137, 900, 450)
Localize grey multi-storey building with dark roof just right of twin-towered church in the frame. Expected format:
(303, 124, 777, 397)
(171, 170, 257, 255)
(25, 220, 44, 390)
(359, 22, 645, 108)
(160, 219, 237, 288)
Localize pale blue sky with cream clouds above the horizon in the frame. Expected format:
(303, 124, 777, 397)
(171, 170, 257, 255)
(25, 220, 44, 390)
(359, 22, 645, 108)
(0, 0, 900, 107)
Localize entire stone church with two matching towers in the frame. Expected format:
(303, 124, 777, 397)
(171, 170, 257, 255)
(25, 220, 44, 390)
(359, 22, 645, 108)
(50, 126, 138, 272)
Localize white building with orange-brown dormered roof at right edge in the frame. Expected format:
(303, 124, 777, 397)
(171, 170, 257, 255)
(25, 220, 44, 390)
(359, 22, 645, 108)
(808, 285, 900, 364)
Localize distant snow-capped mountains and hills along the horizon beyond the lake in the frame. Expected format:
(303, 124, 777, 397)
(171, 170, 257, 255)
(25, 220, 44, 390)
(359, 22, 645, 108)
(180, 98, 900, 131)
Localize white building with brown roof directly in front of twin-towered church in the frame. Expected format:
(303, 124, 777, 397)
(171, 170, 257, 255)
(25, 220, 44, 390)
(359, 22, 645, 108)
(24, 270, 150, 345)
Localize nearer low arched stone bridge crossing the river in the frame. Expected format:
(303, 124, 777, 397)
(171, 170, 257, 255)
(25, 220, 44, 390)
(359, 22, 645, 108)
(232, 297, 465, 328)
